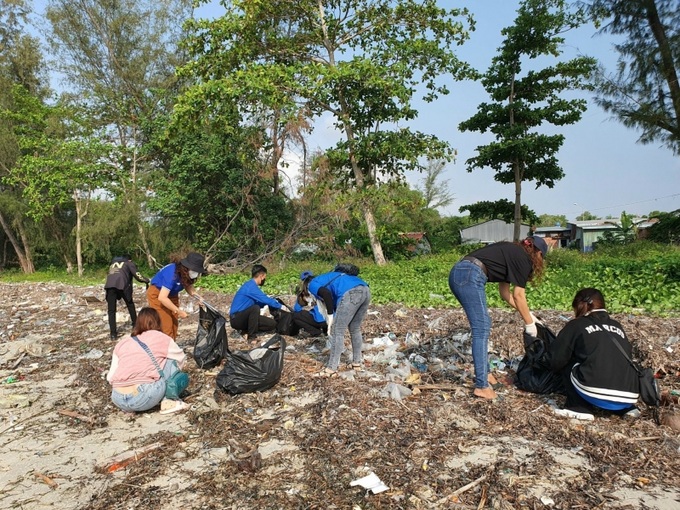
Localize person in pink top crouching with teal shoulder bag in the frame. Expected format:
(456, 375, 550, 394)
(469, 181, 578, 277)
(106, 307, 188, 414)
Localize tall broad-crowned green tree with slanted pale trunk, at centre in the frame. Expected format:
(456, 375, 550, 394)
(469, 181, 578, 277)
(180, 0, 469, 264)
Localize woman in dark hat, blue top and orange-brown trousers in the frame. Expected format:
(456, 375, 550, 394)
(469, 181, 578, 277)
(146, 252, 207, 340)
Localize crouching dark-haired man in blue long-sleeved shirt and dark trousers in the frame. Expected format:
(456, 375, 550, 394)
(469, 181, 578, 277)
(229, 264, 281, 343)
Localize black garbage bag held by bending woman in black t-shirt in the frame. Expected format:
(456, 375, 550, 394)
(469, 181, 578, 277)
(515, 324, 564, 393)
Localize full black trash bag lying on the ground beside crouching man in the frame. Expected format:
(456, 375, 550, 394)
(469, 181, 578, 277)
(217, 335, 286, 395)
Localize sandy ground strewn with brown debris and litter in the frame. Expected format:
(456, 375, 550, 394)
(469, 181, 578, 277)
(0, 284, 680, 510)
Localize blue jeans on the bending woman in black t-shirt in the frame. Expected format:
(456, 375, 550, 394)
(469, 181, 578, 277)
(449, 260, 491, 389)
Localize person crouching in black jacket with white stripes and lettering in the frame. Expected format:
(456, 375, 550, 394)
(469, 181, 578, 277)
(549, 288, 639, 420)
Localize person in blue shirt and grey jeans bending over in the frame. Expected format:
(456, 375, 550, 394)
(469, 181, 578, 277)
(308, 265, 371, 377)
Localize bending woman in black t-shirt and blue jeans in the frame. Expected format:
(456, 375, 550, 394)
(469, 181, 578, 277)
(449, 236, 548, 399)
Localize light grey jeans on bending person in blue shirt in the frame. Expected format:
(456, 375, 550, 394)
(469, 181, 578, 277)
(328, 285, 371, 370)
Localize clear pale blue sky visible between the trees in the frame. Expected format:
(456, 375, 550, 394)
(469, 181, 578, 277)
(34, 0, 680, 220)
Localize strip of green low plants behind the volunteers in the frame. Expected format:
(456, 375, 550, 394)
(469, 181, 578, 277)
(5, 242, 680, 316)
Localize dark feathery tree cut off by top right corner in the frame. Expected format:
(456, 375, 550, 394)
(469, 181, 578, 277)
(583, 0, 680, 154)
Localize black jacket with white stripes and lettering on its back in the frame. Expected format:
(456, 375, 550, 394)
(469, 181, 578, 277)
(549, 312, 639, 403)
